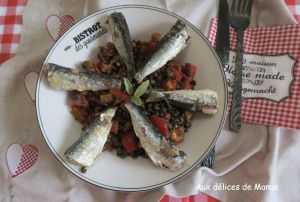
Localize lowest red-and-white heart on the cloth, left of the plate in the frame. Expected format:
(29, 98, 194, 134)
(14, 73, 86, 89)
(5, 143, 38, 178)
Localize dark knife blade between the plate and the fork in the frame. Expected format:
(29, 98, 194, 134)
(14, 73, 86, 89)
(216, 0, 230, 68)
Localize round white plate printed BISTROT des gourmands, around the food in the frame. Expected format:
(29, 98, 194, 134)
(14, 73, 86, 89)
(36, 5, 227, 191)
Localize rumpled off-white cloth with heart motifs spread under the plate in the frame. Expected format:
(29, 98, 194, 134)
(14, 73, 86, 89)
(0, 0, 300, 202)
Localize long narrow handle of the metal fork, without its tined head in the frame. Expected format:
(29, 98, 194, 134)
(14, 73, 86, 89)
(229, 30, 244, 132)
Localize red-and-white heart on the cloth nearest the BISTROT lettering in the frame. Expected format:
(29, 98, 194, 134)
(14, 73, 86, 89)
(46, 15, 74, 41)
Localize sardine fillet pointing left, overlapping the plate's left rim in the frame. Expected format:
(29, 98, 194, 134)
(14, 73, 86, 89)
(45, 63, 122, 91)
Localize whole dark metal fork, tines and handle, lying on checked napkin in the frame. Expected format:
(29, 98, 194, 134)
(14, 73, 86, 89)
(229, 0, 253, 132)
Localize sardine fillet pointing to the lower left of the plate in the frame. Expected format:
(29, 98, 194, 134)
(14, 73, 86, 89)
(65, 108, 116, 167)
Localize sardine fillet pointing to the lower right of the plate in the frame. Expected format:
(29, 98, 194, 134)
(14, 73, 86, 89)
(125, 103, 187, 171)
